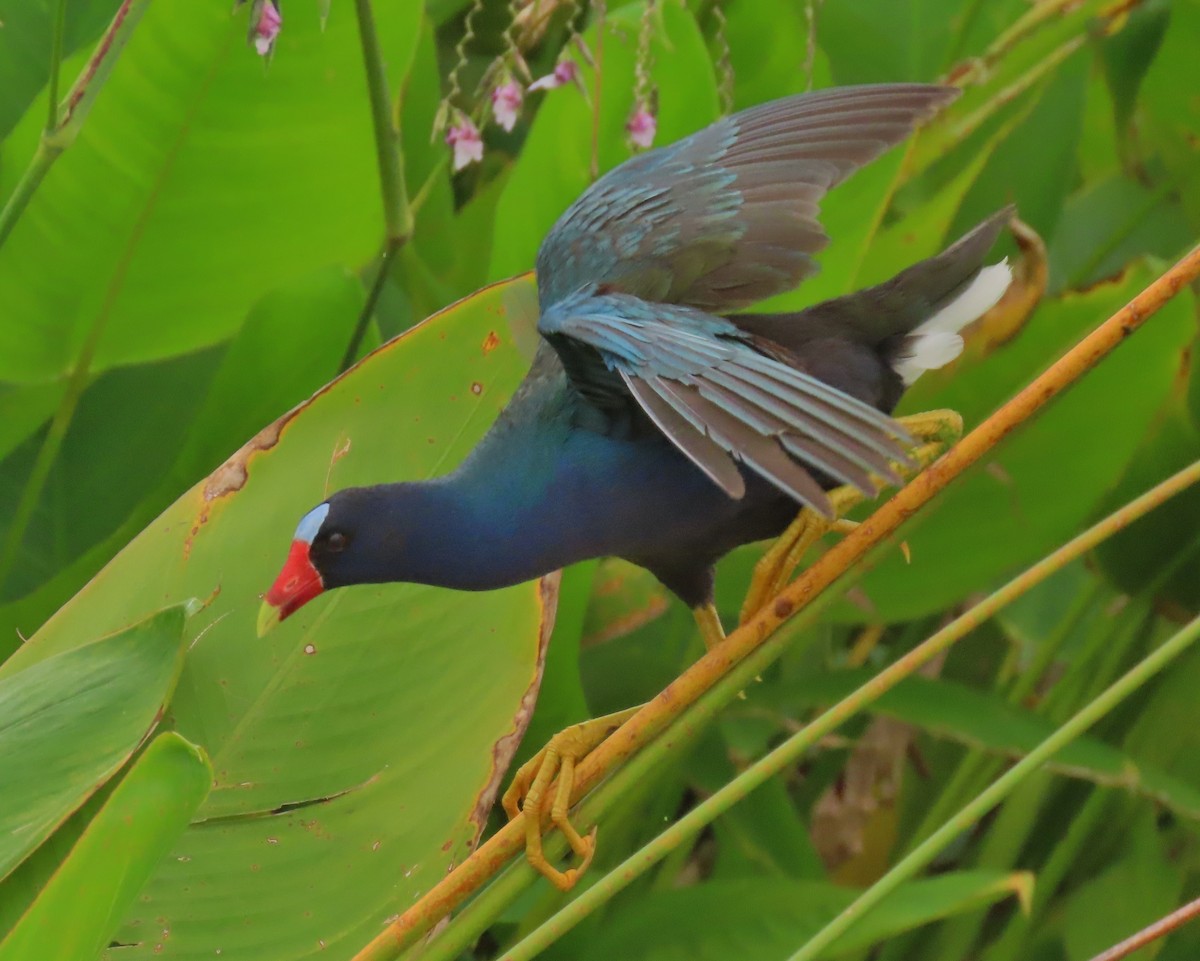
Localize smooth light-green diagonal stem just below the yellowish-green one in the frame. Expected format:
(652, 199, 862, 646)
(788, 617, 1200, 961)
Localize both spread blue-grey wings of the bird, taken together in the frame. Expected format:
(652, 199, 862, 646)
(538, 84, 958, 516)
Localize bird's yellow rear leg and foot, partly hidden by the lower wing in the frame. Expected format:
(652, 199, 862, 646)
(739, 410, 962, 624)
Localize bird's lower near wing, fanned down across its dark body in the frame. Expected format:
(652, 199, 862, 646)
(539, 289, 911, 516)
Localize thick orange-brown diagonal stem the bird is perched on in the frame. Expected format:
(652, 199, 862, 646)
(355, 239, 1200, 961)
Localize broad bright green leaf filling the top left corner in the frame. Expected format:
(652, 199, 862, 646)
(0, 0, 421, 383)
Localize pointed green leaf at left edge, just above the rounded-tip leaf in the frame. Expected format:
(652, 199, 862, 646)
(0, 607, 184, 878)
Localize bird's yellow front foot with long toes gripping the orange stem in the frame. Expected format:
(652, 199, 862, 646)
(503, 708, 640, 891)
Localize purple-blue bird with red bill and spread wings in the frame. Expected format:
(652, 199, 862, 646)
(258, 83, 1012, 887)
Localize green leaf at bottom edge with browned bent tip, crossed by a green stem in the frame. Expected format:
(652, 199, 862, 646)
(558, 871, 1032, 961)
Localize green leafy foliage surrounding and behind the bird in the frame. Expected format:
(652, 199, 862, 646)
(0, 0, 1200, 961)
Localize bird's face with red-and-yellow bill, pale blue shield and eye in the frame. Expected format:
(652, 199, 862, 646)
(258, 494, 356, 637)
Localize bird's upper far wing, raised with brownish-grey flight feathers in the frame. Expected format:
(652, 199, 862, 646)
(538, 84, 958, 312)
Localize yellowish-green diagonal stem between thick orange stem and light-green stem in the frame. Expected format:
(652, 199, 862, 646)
(484, 461, 1200, 961)
